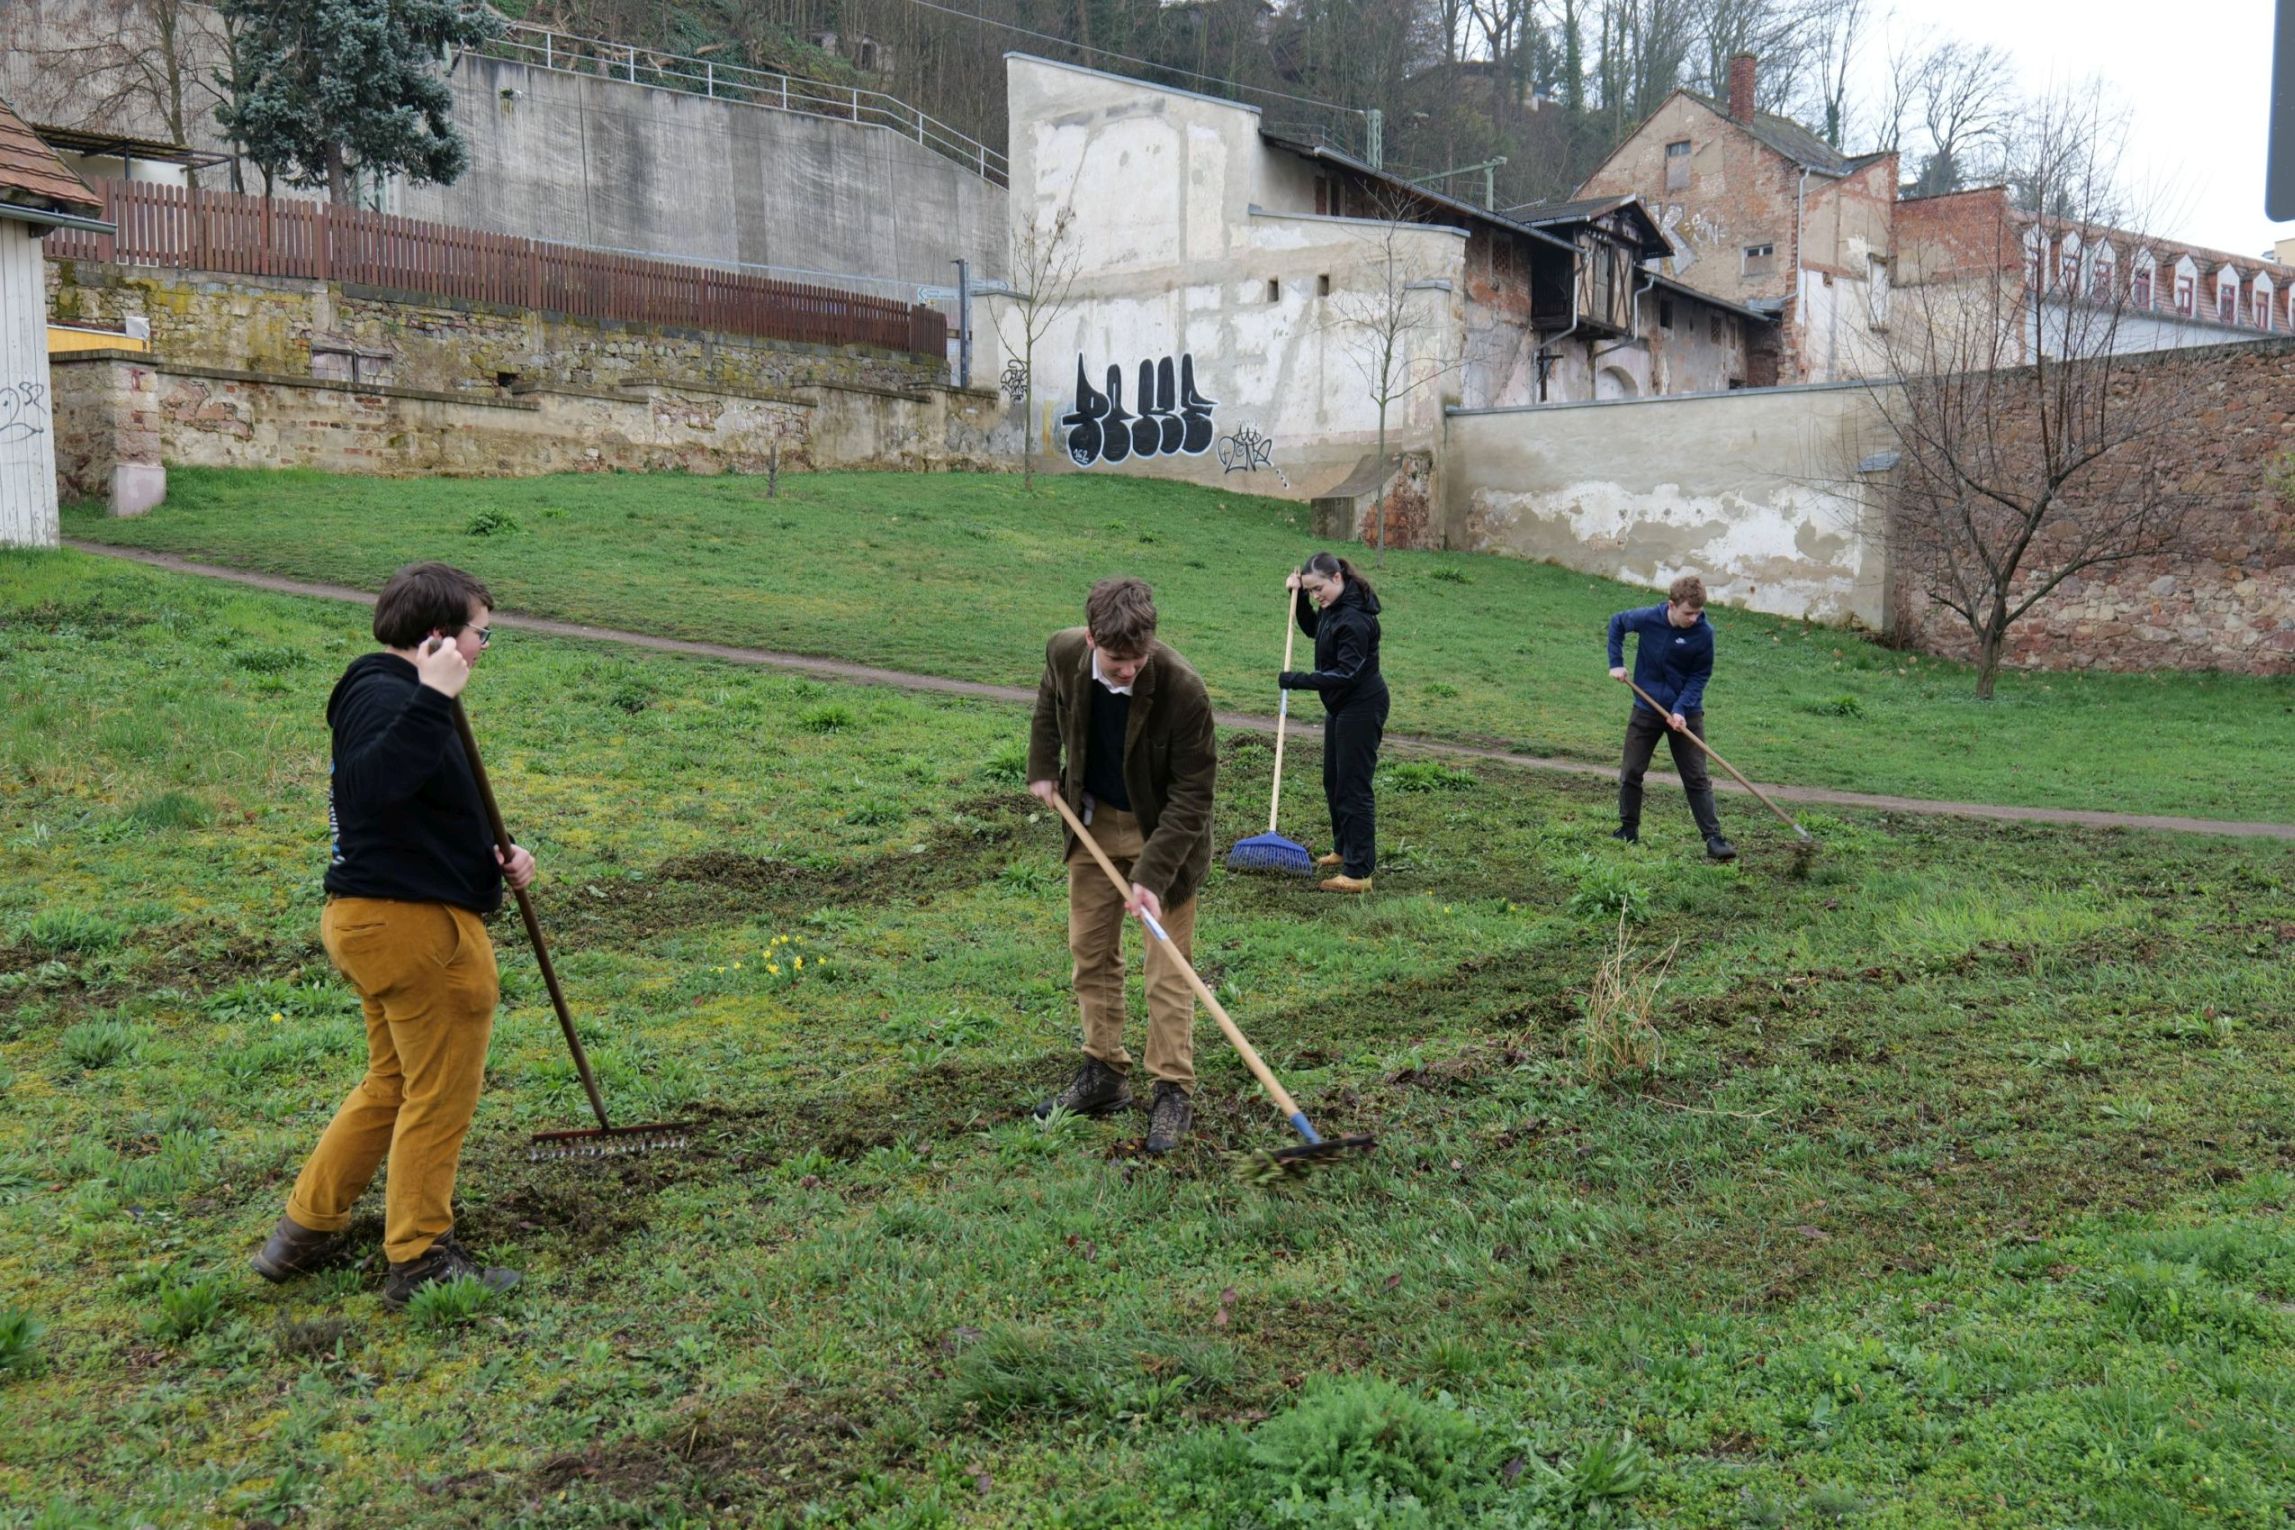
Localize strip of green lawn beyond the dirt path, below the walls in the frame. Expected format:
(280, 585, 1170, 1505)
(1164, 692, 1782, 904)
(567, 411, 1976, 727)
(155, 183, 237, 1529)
(64, 470, 2295, 821)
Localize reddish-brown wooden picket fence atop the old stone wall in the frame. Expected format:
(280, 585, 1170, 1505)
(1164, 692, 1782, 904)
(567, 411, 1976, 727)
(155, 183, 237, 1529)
(46, 181, 948, 358)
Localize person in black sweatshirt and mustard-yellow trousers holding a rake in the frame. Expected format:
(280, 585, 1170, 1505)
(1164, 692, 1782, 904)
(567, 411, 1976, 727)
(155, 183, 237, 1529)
(255, 562, 535, 1307)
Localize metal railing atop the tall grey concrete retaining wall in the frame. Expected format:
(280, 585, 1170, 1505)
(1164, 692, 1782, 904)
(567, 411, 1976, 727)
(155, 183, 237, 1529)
(477, 21, 1012, 186)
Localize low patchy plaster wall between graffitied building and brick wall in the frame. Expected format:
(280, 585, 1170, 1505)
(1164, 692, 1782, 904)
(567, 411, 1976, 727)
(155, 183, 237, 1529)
(1444, 385, 1886, 629)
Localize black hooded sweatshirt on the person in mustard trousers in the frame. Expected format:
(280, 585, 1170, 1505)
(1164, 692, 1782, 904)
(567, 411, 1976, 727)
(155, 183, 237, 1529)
(326, 654, 503, 913)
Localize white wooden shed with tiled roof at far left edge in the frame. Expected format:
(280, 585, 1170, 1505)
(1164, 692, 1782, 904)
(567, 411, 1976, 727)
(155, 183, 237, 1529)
(0, 101, 110, 548)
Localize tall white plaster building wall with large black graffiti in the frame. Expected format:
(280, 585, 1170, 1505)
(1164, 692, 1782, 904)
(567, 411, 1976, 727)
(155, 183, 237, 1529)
(1005, 55, 1467, 498)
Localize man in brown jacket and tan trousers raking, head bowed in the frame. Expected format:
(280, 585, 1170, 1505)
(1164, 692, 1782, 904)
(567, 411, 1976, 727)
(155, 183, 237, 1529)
(1028, 578, 1219, 1154)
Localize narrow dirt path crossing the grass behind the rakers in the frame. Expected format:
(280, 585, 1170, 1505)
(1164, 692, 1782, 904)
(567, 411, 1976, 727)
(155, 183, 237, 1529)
(64, 539, 2295, 842)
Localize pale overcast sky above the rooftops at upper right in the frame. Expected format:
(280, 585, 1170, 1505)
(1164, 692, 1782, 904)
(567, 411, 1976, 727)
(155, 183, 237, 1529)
(1850, 0, 2295, 255)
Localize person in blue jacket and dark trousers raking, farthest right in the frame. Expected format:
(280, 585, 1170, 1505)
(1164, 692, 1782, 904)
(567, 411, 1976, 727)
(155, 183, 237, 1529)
(1609, 573, 1737, 860)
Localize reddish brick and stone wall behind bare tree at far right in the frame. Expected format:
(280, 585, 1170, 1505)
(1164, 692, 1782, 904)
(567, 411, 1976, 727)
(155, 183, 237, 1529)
(1893, 339, 2295, 674)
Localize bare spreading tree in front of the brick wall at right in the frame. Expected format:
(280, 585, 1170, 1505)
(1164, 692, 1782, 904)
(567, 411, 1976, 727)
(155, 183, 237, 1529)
(1873, 92, 2189, 700)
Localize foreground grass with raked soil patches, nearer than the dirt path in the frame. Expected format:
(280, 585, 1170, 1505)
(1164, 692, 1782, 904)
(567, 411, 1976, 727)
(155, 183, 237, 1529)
(0, 552, 2295, 1530)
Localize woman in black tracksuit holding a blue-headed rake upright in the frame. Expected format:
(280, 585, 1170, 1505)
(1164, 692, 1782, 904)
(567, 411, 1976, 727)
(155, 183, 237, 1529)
(1281, 553, 1386, 892)
